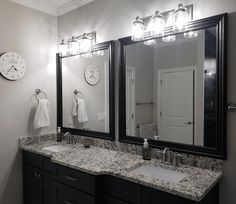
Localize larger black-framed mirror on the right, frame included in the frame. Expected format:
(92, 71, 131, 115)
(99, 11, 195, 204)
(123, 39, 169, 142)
(119, 14, 227, 159)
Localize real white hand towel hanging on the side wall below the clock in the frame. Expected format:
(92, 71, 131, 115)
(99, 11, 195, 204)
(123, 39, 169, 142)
(34, 99, 50, 129)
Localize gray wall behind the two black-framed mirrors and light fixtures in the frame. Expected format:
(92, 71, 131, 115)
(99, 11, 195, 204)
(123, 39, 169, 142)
(58, 0, 236, 204)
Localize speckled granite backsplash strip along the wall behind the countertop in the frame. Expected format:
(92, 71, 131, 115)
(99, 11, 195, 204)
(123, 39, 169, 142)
(19, 134, 223, 171)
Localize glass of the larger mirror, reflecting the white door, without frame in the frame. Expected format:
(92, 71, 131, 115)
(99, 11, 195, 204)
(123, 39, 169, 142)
(125, 27, 218, 148)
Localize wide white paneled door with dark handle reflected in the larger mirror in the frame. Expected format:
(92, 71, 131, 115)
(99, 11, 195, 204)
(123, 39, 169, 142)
(158, 68, 194, 144)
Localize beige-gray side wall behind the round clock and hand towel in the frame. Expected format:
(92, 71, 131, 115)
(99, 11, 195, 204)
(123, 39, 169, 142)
(0, 0, 57, 204)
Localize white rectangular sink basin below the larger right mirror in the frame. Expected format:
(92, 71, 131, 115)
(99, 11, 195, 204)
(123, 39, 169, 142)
(129, 164, 187, 183)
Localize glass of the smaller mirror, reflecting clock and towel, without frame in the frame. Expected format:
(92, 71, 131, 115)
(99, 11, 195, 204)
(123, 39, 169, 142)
(62, 49, 110, 133)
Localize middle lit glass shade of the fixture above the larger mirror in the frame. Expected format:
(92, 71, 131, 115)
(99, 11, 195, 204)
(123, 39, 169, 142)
(152, 11, 165, 37)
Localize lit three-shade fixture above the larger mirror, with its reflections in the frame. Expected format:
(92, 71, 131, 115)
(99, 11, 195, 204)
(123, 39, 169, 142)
(131, 4, 193, 45)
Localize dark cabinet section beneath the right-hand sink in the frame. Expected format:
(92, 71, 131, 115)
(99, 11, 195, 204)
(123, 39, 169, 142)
(103, 176, 219, 204)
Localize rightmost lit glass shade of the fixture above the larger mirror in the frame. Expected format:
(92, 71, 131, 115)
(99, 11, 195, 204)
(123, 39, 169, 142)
(174, 4, 188, 31)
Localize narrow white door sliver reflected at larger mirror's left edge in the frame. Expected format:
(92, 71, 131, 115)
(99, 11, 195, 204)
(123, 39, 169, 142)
(126, 66, 135, 135)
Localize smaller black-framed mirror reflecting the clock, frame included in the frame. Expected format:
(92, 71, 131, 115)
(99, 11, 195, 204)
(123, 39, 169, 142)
(57, 41, 115, 140)
